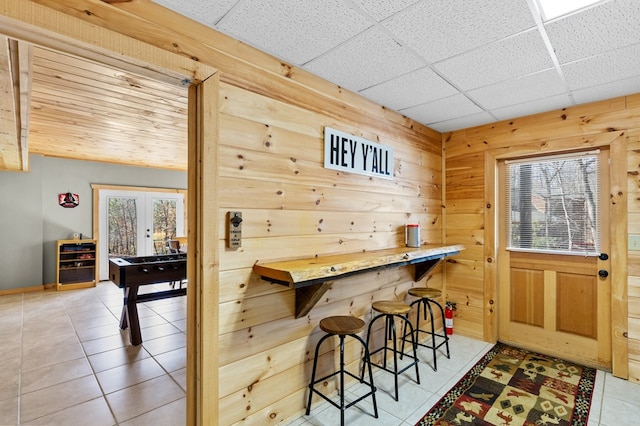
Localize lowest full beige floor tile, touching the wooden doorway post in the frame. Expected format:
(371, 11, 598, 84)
(107, 376, 185, 422)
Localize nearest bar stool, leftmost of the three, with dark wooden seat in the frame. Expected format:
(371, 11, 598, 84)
(306, 316, 378, 425)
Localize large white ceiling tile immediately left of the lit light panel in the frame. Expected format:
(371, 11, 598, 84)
(383, 0, 535, 62)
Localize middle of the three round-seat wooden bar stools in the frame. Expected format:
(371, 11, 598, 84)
(362, 300, 420, 401)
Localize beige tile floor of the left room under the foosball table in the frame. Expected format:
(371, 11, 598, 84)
(0, 282, 186, 426)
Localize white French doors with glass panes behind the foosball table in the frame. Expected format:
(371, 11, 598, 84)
(98, 189, 185, 280)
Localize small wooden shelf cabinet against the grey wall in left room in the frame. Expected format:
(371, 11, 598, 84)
(56, 240, 97, 290)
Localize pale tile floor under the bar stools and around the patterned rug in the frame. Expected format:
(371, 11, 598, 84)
(289, 334, 640, 426)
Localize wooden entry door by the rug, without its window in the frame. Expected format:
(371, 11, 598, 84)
(498, 150, 612, 369)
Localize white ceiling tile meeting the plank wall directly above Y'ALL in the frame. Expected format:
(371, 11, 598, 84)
(360, 67, 458, 110)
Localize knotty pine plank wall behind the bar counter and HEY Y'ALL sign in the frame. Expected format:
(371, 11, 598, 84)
(219, 83, 442, 424)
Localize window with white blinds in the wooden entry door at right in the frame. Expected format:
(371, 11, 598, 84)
(505, 152, 600, 255)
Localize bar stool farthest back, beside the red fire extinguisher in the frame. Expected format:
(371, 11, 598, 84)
(402, 287, 451, 371)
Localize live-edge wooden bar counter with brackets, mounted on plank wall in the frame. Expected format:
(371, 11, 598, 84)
(253, 245, 464, 318)
